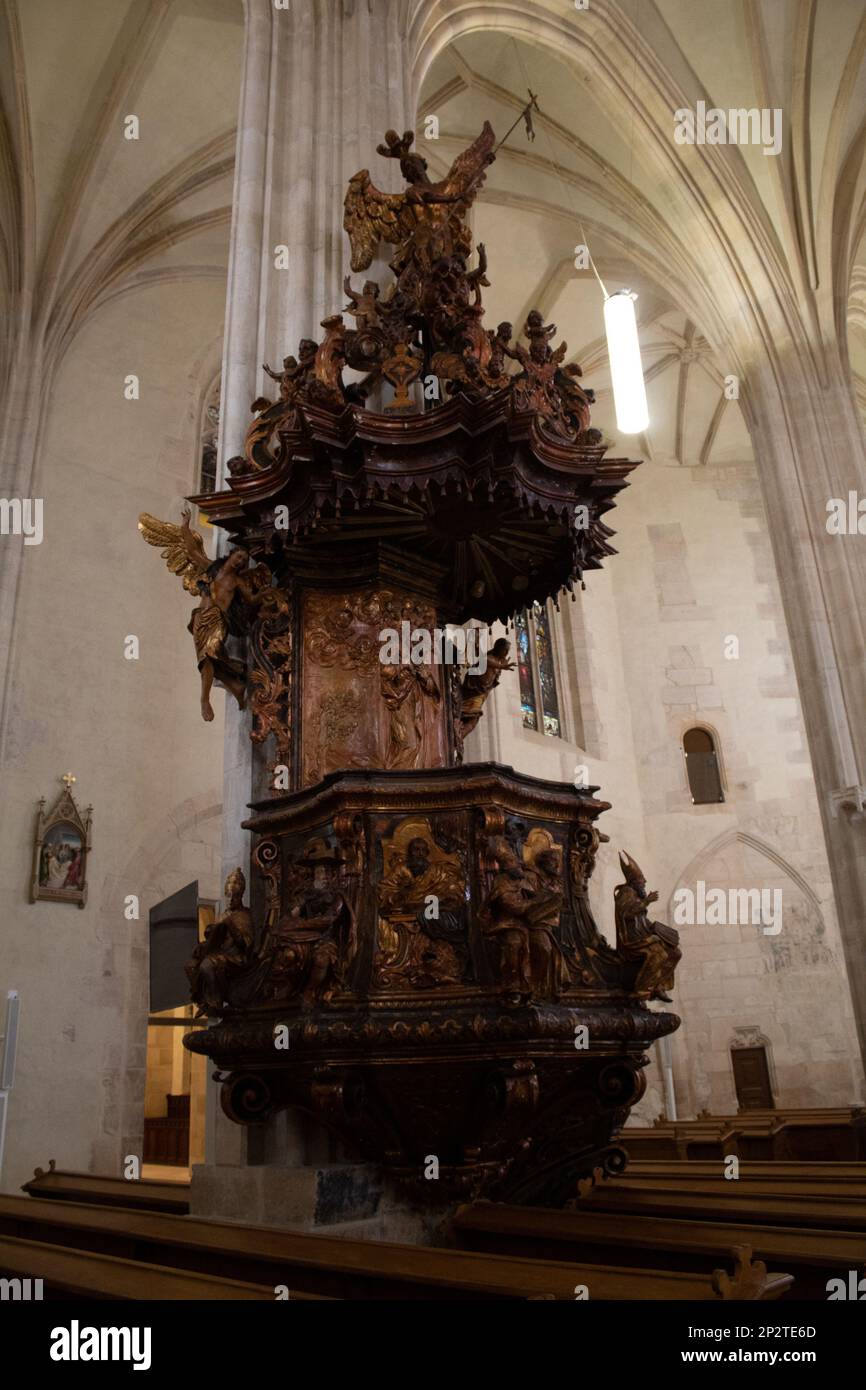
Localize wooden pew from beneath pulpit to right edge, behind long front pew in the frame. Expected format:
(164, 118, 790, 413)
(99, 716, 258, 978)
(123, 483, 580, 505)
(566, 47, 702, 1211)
(450, 1201, 866, 1300)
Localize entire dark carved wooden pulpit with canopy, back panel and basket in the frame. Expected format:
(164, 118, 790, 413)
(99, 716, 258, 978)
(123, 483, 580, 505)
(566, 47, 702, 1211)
(169, 125, 678, 1204)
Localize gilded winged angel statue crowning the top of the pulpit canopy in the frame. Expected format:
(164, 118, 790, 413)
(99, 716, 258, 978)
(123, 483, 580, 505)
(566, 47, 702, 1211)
(343, 121, 495, 278)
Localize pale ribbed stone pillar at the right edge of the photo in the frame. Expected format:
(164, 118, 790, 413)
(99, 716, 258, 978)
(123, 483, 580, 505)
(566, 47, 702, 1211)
(742, 342, 866, 1073)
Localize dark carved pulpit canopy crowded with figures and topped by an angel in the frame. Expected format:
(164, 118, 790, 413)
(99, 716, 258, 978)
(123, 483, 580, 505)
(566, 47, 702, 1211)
(193, 124, 637, 623)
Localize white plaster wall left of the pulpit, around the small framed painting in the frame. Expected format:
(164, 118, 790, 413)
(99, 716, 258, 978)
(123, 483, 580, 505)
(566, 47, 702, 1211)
(0, 281, 224, 1188)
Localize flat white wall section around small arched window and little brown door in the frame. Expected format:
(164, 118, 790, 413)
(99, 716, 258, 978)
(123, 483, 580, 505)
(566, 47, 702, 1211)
(616, 459, 863, 1113)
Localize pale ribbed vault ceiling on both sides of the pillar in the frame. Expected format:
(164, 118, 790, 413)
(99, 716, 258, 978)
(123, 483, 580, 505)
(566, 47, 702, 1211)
(0, 0, 866, 444)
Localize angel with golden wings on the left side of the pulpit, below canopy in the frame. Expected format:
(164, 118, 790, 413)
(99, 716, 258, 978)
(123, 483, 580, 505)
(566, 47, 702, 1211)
(139, 509, 285, 721)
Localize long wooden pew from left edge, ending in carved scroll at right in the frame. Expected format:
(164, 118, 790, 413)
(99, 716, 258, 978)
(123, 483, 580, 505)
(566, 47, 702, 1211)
(0, 1197, 792, 1301)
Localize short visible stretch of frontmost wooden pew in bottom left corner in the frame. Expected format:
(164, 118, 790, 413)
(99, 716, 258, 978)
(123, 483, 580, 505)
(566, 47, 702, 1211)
(0, 1234, 328, 1315)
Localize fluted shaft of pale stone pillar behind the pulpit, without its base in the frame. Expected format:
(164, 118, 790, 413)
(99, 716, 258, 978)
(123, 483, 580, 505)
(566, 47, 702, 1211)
(220, 0, 414, 873)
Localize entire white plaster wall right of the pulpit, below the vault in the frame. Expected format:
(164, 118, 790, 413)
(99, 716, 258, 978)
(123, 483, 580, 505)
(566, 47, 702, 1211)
(467, 441, 862, 1123)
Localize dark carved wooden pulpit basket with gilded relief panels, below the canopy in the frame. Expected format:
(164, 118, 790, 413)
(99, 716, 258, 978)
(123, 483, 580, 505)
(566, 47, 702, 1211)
(189, 763, 677, 1202)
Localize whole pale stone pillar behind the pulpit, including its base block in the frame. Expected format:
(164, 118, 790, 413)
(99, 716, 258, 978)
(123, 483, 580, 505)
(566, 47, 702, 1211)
(192, 0, 414, 1233)
